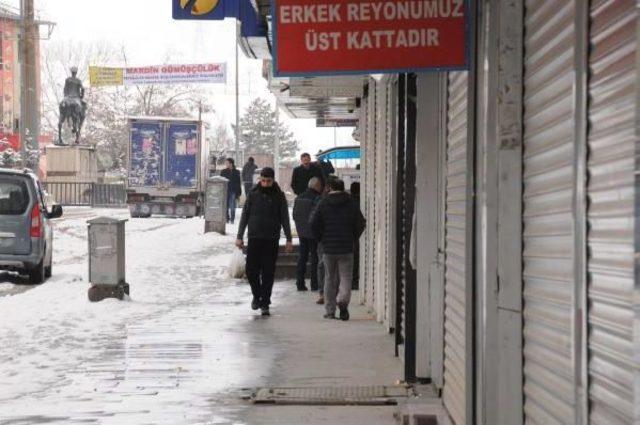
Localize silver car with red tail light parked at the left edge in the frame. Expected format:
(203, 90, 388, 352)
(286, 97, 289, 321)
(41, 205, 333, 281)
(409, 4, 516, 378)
(0, 168, 62, 284)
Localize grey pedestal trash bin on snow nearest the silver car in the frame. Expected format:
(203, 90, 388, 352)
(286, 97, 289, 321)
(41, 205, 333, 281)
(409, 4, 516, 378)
(87, 217, 129, 301)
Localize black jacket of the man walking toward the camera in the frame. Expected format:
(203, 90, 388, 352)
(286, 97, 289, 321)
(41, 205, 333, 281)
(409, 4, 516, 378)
(238, 183, 291, 241)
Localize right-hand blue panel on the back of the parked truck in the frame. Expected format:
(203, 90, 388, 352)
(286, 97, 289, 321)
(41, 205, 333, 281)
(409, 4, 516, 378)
(166, 124, 200, 187)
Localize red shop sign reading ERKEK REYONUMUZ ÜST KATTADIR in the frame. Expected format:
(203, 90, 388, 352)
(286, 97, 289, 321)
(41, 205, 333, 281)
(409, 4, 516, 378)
(273, 0, 469, 77)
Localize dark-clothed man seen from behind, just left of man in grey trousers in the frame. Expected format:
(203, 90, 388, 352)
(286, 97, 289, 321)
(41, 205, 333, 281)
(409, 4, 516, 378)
(293, 177, 322, 291)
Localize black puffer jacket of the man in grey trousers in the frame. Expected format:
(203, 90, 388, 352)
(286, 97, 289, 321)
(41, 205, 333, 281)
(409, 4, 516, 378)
(310, 192, 366, 255)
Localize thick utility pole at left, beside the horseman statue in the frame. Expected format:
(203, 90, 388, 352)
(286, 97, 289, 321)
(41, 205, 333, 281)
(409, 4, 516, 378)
(19, 0, 40, 171)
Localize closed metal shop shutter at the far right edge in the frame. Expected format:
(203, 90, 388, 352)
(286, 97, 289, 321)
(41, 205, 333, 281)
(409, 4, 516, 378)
(587, 0, 640, 425)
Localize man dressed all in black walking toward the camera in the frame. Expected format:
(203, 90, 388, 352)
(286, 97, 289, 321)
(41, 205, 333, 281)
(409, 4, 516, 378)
(236, 167, 293, 316)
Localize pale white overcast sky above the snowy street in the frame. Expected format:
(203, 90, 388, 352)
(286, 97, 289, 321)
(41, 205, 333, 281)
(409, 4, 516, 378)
(13, 0, 354, 153)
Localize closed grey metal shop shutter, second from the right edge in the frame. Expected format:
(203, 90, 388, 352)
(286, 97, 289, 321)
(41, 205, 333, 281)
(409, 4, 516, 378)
(523, 0, 576, 425)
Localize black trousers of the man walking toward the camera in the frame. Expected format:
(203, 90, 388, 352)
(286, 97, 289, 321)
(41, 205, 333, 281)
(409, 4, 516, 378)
(247, 239, 280, 307)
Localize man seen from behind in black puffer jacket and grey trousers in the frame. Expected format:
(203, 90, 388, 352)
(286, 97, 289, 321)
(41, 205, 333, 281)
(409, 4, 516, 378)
(310, 179, 365, 320)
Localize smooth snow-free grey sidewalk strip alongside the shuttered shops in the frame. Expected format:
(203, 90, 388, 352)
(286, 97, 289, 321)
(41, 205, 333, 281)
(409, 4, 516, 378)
(239, 282, 402, 425)
